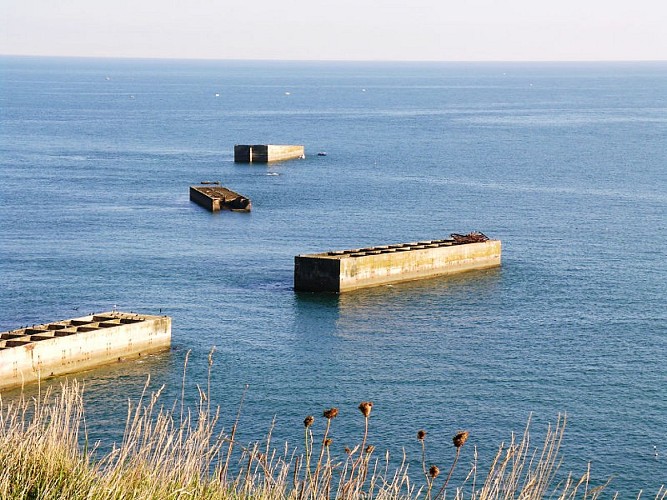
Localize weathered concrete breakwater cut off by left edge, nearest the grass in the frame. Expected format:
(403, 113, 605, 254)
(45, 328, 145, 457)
(0, 311, 171, 390)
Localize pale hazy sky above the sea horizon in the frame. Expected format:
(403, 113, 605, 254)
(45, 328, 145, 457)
(0, 0, 667, 61)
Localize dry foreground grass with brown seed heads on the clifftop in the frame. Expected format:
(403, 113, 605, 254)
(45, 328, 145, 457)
(0, 353, 667, 500)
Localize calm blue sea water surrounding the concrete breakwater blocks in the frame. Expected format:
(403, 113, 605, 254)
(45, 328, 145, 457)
(0, 57, 667, 495)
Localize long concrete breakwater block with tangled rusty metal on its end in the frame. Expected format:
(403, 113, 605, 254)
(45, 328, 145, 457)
(294, 233, 502, 292)
